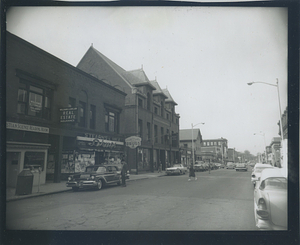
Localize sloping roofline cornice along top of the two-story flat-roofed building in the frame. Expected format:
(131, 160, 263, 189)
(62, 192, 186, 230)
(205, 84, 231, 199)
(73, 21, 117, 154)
(6, 31, 127, 96)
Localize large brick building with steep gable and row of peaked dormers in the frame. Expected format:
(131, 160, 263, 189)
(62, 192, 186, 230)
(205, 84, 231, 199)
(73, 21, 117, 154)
(77, 46, 179, 173)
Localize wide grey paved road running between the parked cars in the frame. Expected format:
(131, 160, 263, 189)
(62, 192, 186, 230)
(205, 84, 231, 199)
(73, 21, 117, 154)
(6, 169, 256, 231)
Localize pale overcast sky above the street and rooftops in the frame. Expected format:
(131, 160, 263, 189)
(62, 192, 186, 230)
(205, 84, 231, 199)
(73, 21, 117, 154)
(7, 7, 287, 155)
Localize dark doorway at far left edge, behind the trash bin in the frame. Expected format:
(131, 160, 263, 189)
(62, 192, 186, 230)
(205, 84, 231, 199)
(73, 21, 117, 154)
(6, 152, 21, 187)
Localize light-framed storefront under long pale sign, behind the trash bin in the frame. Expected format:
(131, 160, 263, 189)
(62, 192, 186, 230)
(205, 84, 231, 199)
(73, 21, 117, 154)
(6, 122, 50, 187)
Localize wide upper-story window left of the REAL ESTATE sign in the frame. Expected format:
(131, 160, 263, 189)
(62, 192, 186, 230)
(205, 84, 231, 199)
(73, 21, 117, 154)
(17, 82, 52, 120)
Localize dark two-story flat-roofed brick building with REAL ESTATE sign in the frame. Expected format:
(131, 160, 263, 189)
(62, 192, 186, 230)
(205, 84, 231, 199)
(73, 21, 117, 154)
(6, 32, 126, 187)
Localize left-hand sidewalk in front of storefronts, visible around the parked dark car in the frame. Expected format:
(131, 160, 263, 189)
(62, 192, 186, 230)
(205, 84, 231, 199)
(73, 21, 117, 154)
(6, 172, 165, 202)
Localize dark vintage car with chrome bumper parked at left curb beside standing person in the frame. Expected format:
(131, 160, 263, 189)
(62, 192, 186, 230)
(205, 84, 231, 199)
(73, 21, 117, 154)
(66, 165, 122, 191)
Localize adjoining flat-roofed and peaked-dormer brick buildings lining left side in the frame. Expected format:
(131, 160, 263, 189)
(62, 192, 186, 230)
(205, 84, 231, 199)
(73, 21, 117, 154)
(6, 32, 180, 186)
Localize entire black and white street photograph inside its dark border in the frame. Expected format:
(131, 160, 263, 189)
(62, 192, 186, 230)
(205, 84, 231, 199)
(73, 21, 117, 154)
(3, 0, 299, 244)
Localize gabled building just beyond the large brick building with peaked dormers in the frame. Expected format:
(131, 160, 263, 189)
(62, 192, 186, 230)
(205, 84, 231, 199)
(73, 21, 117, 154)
(179, 128, 202, 166)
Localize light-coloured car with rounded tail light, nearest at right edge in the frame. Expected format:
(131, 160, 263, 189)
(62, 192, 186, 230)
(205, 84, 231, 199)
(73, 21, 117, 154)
(254, 168, 287, 230)
